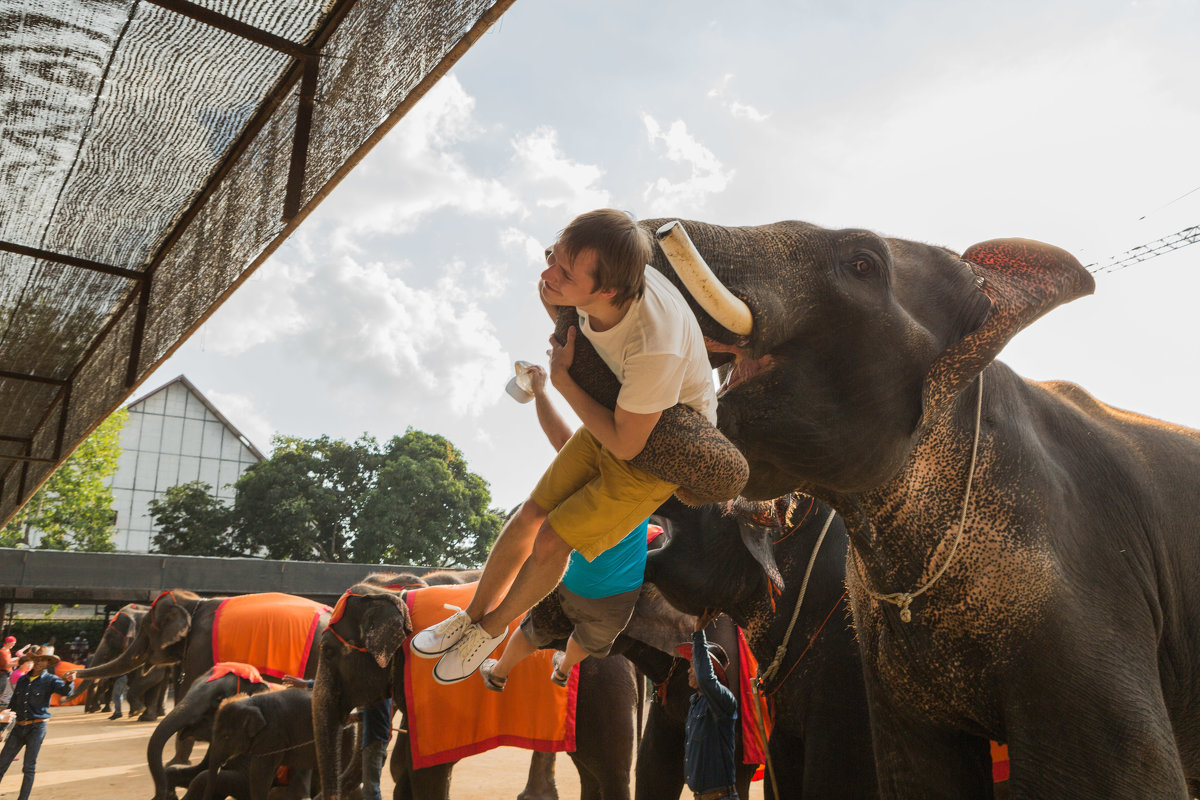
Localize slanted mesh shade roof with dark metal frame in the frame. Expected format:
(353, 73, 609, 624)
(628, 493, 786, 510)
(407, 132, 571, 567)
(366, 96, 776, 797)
(0, 0, 512, 523)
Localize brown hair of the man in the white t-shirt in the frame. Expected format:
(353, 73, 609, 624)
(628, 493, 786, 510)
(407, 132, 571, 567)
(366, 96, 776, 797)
(554, 209, 653, 306)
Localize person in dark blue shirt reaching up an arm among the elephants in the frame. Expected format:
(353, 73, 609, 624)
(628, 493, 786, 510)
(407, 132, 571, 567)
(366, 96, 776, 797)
(677, 609, 738, 800)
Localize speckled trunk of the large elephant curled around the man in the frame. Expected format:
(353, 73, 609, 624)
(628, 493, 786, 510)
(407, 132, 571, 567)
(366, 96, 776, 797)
(554, 307, 750, 505)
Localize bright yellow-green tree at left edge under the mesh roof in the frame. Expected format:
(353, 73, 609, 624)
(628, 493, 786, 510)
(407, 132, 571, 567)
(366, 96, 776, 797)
(0, 408, 130, 553)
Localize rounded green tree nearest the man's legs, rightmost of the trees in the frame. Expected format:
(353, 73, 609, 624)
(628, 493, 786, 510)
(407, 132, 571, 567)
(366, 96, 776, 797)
(354, 428, 504, 567)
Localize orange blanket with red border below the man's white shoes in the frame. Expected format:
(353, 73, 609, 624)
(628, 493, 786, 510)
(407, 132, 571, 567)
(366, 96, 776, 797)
(404, 583, 580, 766)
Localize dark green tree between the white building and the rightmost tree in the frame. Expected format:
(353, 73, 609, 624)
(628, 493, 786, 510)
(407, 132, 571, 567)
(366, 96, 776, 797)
(234, 435, 379, 561)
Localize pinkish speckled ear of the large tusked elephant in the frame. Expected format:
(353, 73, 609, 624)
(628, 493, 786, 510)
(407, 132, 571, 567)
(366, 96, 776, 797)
(923, 239, 1096, 423)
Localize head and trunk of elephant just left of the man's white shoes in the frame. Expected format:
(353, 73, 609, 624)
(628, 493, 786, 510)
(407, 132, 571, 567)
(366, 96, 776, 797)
(312, 576, 413, 798)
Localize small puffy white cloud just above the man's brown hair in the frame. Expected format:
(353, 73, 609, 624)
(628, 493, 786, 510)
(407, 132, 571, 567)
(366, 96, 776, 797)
(512, 125, 612, 215)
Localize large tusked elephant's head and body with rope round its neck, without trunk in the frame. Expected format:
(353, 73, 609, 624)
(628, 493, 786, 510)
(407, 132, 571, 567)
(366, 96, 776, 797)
(648, 215, 1200, 799)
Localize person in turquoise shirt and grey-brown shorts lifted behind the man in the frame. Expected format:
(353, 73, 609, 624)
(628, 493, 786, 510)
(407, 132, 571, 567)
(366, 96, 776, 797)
(479, 366, 647, 692)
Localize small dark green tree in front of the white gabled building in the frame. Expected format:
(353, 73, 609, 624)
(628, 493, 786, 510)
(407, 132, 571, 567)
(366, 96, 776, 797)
(148, 481, 241, 555)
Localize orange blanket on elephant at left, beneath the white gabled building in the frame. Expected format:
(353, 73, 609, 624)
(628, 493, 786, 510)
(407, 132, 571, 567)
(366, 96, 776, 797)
(212, 591, 329, 678)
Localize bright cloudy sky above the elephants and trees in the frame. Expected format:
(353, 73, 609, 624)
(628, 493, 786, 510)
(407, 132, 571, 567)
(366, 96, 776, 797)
(137, 0, 1200, 507)
